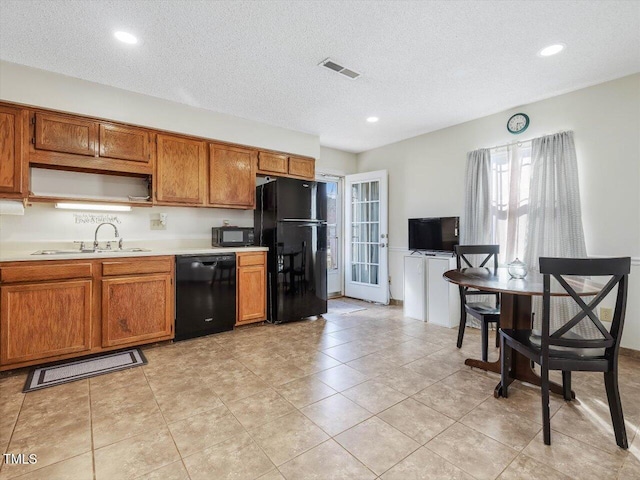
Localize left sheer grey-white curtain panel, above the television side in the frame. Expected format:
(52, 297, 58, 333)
(460, 148, 493, 245)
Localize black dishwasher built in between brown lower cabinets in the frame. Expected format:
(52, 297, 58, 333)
(175, 253, 236, 340)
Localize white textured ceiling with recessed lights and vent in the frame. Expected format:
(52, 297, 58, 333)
(0, 0, 640, 152)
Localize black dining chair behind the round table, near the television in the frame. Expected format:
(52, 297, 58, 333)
(455, 245, 500, 362)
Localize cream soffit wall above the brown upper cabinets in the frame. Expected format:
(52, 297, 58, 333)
(0, 61, 320, 158)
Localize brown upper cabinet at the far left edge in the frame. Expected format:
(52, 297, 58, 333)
(0, 105, 26, 198)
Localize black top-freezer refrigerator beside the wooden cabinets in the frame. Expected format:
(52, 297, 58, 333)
(254, 178, 327, 323)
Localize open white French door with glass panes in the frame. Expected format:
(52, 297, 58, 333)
(344, 170, 389, 304)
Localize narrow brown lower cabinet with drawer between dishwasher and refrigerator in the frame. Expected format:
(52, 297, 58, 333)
(236, 252, 267, 325)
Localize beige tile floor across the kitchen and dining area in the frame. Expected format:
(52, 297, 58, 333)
(0, 299, 640, 480)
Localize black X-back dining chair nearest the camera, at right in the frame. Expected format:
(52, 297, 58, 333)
(500, 257, 631, 449)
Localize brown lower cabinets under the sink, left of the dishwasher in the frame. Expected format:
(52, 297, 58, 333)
(0, 256, 174, 371)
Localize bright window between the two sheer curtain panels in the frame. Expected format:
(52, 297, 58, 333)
(490, 141, 531, 264)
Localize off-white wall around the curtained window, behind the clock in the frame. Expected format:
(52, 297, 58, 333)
(358, 74, 640, 349)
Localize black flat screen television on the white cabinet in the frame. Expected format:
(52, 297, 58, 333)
(409, 217, 460, 252)
